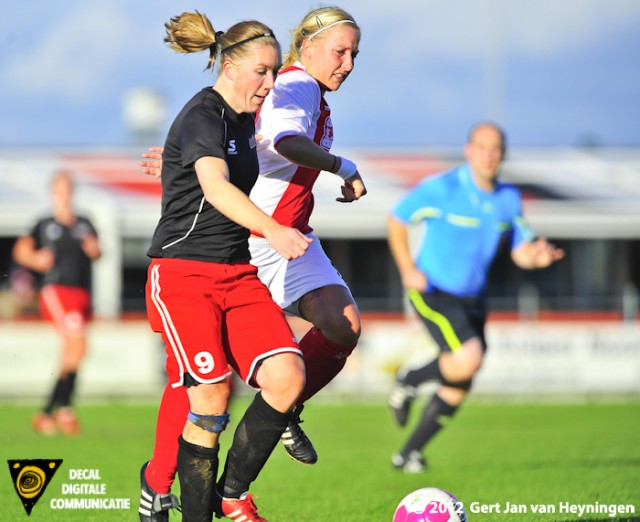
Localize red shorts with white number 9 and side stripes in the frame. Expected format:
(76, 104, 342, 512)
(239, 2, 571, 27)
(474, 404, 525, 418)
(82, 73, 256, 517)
(146, 258, 302, 387)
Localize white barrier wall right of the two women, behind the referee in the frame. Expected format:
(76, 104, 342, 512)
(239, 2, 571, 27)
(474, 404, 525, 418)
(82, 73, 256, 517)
(336, 314, 640, 395)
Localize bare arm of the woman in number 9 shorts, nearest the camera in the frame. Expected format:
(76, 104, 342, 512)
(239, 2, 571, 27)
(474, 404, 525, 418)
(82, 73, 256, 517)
(195, 156, 311, 259)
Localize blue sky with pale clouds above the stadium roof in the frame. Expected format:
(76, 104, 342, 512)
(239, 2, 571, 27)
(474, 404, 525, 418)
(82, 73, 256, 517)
(0, 0, 640, 148)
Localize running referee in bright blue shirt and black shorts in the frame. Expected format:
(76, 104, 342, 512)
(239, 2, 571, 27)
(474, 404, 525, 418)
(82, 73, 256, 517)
(388, 123, 564, 473)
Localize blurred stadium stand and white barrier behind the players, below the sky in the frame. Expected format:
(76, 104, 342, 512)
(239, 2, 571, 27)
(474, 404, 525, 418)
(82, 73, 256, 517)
(0, 147, 640, 398)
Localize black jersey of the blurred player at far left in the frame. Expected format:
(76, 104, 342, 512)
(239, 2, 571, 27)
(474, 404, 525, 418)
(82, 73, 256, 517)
(30, 216, 98, 289)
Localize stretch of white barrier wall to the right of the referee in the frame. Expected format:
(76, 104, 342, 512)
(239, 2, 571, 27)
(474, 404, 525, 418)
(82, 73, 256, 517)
(477, 323, 640, 393)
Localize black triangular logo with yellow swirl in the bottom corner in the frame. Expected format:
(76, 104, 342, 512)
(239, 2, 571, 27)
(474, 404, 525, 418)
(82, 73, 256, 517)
(7, 459, 62, 515)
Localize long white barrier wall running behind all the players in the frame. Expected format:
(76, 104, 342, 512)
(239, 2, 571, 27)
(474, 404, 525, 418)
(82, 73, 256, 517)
(0, 319, 640, 398)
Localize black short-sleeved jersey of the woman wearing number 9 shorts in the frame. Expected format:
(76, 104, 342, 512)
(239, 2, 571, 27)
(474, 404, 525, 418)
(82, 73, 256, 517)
(147, 87, 259, 263)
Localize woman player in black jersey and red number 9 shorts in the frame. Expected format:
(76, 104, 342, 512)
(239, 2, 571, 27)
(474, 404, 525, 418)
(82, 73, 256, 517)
(139, 12, 311, 522)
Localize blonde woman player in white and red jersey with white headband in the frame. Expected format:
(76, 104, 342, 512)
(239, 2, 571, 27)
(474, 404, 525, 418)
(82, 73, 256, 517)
(141, 7, 366, 481)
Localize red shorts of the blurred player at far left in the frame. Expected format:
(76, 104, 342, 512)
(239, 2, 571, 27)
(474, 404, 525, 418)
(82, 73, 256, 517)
(38, 285, 91, 335)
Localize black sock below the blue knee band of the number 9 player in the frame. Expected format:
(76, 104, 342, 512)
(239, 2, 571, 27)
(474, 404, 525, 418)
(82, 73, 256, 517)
(178, 435, 219, 522)
